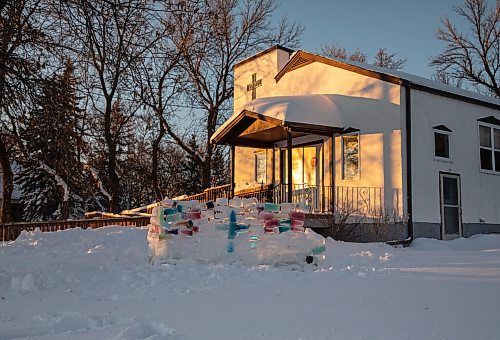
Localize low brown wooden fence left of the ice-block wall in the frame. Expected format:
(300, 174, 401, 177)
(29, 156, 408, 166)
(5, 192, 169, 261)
(0, 216, 150, 241)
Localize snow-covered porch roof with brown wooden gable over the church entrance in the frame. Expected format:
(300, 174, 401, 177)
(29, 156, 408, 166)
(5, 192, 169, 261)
(211, 94, 390, 148)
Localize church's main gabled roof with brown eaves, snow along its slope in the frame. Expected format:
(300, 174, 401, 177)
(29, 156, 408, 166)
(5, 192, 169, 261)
(275, 50, 500, 110)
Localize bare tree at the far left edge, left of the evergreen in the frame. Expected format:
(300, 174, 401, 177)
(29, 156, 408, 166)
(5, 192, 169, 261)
(0, 0, 47, 222)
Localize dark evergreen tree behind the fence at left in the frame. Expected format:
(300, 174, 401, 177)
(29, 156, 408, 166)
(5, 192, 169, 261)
(19, 61, 85, 220)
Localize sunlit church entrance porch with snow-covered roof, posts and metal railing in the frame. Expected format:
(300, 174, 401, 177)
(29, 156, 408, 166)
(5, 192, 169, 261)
(212, 95, 403, 219)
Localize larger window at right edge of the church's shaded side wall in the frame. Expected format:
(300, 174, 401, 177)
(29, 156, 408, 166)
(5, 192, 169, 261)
(479, 125, 500, 172)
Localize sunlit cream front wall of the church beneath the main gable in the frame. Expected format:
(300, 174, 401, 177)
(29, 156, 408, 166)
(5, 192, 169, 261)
(276, 62, 404, 216)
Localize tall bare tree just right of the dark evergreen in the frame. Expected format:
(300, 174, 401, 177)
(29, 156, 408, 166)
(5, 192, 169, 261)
(61, 0, 158, 212)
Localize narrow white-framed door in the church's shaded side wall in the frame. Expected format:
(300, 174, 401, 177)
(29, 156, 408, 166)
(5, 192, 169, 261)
(439, 173, 462, 240)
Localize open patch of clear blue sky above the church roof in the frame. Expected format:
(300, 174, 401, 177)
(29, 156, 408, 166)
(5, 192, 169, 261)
(278, 0, 470, 78)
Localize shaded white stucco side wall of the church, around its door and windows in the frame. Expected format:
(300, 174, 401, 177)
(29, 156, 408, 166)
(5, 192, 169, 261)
(411, 90, 500, 223)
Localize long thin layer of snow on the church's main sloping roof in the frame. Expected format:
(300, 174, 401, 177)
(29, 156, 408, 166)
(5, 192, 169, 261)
(302, 51, 500, 105)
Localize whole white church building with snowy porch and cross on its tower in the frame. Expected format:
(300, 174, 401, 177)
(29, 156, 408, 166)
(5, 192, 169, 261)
(212, 46, 500, 239)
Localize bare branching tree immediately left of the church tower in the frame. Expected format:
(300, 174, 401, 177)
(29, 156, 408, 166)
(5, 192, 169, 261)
(165, 0, 303, 188)
